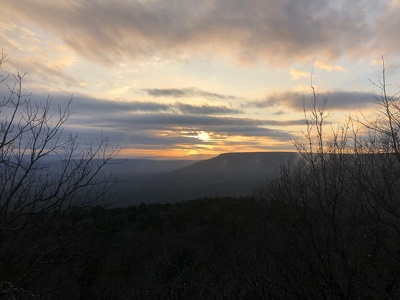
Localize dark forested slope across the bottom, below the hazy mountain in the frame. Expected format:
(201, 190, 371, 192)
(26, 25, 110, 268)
(1, 189, 400, 299)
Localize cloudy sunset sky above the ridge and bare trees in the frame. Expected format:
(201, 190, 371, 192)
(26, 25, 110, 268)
(0, 0, 400, 159)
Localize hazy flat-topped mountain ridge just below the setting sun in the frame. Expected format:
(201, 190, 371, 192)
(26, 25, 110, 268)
(115, 152, 298, 205)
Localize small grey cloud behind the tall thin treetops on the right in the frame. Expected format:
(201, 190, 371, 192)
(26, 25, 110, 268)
(247, 91, 377, 111)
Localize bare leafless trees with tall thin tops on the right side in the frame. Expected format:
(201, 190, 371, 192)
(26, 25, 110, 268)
(255, 63, 400, 299)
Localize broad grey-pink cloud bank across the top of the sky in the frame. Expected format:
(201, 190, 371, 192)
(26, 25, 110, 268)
(0, 0, 400, 65)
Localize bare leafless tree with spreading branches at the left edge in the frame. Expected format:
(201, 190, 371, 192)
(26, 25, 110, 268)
(0, 53, 118, 297)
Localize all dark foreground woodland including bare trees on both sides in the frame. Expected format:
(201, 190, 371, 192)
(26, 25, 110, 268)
(0, 51, 400, 299)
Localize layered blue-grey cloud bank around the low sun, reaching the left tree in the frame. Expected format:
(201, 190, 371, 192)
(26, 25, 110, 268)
(14, 94, 298, 151)
